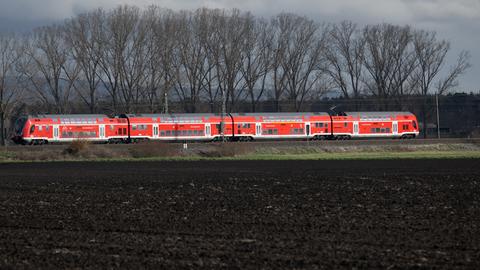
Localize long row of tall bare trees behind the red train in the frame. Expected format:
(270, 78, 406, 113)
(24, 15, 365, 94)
(0, 6, 470, 143)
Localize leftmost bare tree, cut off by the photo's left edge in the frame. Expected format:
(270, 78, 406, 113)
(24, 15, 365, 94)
(0, 35, 23, 145)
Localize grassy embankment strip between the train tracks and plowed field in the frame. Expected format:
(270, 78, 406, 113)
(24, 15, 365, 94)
(0, 141, 480, 162)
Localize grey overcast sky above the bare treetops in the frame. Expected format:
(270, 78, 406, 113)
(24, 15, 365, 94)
(0, 0, 480, 92)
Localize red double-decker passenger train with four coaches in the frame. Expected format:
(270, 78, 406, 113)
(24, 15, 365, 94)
(12, 112, 419, 144)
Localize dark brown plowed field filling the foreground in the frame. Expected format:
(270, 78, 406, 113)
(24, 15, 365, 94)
(0, 159, 480, 269)
